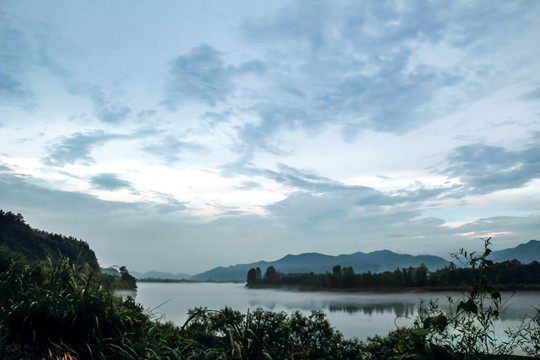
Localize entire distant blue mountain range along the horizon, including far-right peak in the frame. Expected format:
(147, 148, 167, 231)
(132, 240, 540, 281)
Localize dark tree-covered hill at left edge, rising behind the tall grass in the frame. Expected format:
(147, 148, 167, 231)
(0, 210, 99, 270)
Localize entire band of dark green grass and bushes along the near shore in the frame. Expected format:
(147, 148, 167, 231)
(0, 241, 540, 360)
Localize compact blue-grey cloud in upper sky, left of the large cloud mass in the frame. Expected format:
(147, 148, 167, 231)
(164, 44, 265, 108)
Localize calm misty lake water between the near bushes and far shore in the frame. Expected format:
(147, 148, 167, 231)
(118, 283, 540, 339)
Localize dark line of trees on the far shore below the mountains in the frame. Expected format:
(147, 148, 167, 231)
(247, 260, 540, 290)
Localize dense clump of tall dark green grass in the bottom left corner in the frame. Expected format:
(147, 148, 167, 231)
(0, 251, 155, 359)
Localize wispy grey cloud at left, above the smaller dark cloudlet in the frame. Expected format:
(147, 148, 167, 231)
(42, 130, 119, 166)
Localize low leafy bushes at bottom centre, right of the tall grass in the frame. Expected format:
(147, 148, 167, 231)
(182, 308, 363, 360)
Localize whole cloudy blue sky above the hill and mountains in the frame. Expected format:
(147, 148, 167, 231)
(0, 0, 540, 274)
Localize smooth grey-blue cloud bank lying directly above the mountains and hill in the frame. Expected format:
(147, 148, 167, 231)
(0, 164, 539, 273)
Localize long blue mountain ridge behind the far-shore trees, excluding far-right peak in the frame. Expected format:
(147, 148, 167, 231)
(191, 250, 448, 281)
